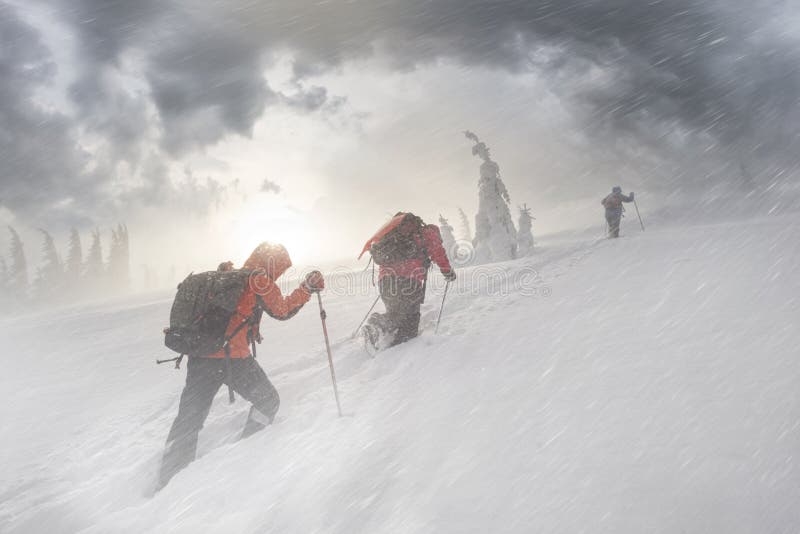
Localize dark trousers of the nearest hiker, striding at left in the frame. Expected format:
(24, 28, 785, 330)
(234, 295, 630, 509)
(159, 357, 280, 487)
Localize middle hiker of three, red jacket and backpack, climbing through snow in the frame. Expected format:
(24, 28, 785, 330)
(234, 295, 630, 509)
(359, 212, 456, 350)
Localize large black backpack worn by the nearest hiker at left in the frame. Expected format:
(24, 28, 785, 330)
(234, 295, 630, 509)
(164, 270, 252, 357)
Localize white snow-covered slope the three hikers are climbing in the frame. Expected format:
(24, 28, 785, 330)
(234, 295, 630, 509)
(0, 216, 800, 534)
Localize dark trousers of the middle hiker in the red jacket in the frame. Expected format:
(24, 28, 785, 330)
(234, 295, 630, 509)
(370, 276, 425, 346)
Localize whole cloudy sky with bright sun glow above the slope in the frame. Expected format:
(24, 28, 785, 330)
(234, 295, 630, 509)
(0, 0, 800, 280)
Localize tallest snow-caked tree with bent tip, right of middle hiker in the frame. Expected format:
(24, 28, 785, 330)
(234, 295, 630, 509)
(464, 132, 517, 264)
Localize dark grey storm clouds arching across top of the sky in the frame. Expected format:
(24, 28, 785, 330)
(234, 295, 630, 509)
(0, 0, 800, 226)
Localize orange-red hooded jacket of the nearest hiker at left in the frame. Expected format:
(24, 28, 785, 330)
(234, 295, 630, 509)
(208, 243, 311, 358)
